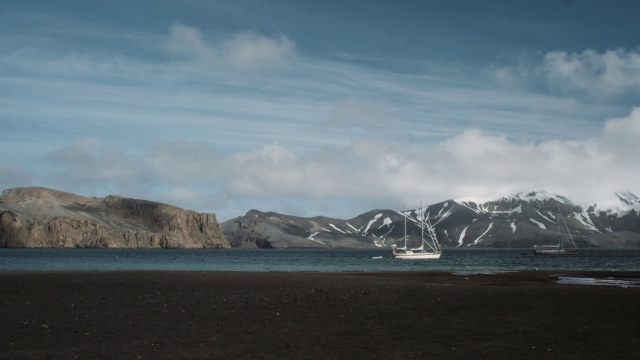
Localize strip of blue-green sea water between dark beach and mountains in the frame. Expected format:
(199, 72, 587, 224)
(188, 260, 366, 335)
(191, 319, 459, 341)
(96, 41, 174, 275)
(0, 249, 640, 272)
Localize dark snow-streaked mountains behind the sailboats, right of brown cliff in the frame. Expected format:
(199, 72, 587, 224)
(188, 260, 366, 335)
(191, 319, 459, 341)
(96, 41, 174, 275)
(222, 190, 640, 248)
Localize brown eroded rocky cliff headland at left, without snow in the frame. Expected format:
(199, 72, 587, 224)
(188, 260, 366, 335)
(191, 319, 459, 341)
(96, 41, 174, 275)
(0, 187, 231, 249)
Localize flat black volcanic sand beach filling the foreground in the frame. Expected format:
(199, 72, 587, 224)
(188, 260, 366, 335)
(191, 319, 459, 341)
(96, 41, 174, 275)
(0, 271, 640, 360)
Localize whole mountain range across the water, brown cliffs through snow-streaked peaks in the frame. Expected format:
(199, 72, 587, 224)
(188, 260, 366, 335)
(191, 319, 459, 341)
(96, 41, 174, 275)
(0, 187, 640, 249)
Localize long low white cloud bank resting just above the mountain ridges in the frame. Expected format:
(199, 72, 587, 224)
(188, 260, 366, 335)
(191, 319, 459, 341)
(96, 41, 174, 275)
(16, 108, 640, 220)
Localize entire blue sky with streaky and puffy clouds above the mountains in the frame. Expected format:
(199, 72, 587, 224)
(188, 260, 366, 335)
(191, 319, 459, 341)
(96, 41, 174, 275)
(0, 0, 640, 221)
